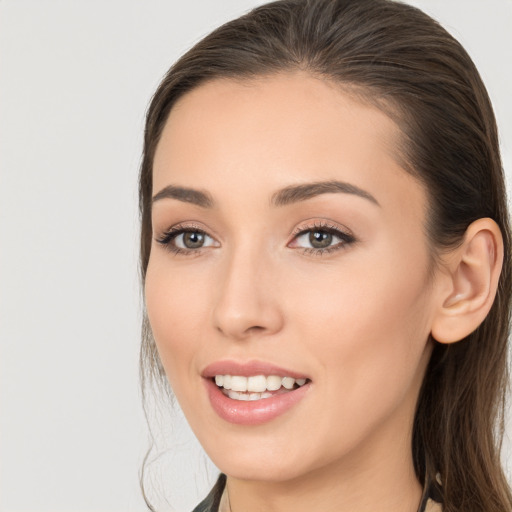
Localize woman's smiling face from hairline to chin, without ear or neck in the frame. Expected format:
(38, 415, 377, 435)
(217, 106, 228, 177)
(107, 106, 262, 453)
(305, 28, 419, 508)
(145, 73, 435, 481)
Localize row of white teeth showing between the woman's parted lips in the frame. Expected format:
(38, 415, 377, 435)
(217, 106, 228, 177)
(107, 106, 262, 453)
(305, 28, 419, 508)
(213, 375, 309, 402)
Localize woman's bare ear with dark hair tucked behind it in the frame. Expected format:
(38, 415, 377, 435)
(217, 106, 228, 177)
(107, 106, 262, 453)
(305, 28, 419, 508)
(431, 218, 503, 343)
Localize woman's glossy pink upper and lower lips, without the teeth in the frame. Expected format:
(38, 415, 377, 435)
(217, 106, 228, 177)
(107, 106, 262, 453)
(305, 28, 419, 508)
(201, 361, 311, 425)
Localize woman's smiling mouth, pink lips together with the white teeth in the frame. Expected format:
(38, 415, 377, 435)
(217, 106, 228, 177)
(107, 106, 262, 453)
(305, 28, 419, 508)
(202, 362, 311, 425)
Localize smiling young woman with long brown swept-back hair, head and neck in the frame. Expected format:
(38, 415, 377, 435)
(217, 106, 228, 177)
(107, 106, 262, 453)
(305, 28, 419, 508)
(140, 0, 512, 512)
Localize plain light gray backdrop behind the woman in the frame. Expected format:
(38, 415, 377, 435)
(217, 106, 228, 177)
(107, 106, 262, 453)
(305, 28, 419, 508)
(0, 0, 512, 512)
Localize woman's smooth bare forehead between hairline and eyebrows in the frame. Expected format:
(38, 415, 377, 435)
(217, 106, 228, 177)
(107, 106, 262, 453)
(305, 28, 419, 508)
(153, 72, 423, 217)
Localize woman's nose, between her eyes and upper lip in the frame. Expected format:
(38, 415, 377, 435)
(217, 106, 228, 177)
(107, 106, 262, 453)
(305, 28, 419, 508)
(213, 243, 284, 340)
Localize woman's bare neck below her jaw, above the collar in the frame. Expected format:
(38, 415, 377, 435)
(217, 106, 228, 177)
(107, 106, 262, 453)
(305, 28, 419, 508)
(227, 420, 422, 512)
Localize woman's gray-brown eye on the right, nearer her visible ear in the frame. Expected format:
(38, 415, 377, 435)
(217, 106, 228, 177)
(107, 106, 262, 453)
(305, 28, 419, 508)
(289, 224, 355, 254)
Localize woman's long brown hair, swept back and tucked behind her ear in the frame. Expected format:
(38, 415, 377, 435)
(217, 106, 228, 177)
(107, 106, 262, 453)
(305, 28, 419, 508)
(140, 0, 512, 512)
